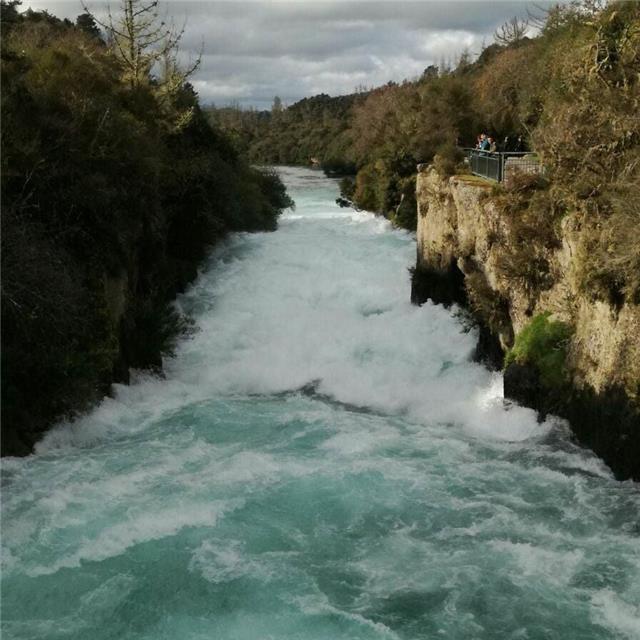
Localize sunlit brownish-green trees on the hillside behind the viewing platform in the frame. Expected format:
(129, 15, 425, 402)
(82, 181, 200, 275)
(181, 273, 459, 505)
(210, 0, 640, 235)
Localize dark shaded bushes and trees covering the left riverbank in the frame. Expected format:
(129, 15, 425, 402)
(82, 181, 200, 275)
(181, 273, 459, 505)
(1, 0, 291, 453)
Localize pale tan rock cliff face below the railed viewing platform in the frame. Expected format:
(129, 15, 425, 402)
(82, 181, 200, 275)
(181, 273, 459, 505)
(413, 166, 640, 479)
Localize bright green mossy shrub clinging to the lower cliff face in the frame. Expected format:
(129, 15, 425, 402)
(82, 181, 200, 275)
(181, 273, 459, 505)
(505, 312, 572, 388)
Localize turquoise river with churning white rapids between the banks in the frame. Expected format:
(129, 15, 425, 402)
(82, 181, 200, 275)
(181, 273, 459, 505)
(2, 169, 640, 640)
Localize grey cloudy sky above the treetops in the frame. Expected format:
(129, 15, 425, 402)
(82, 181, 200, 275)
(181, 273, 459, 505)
(23, 0, 540, 108)
